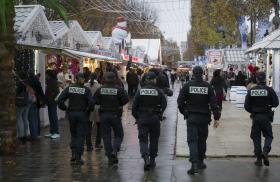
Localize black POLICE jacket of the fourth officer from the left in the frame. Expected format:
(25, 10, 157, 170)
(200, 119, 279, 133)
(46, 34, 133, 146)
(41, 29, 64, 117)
(177, 78, 221, 120)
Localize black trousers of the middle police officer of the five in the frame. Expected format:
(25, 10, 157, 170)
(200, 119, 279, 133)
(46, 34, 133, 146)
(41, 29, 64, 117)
(137, 115, 160, 158)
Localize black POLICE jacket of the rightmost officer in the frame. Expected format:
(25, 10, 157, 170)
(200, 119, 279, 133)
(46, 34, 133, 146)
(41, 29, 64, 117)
(244, 83, 279, 113)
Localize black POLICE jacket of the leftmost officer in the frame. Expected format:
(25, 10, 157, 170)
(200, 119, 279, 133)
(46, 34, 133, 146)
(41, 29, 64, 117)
(57, 84, 94, 112)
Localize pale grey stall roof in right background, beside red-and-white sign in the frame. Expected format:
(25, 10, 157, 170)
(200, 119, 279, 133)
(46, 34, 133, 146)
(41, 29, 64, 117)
(224, 49, 248, 63)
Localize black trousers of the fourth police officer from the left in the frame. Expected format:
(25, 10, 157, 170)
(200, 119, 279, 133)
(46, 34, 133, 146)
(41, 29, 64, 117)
(187, 113, 210, 163)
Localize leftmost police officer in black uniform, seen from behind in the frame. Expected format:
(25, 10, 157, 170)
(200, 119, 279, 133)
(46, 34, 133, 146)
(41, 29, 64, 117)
(57, 73, 94, 165)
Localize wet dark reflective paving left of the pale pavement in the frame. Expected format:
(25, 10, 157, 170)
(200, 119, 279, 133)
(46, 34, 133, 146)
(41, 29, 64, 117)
(0, 85, 177, 182)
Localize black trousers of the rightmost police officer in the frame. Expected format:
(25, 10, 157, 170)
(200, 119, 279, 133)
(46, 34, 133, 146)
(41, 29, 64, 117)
(251, 114, 273, 159)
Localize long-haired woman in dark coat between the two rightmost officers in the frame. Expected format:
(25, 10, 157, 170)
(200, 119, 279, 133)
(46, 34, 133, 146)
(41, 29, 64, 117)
(210, 69, 227, 111)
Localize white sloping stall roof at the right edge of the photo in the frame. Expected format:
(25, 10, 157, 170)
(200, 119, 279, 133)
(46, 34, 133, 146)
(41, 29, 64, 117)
(246, 29, 280, 53)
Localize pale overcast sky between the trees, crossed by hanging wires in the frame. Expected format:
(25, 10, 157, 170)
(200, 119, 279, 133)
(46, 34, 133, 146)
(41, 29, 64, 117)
(144, 0, 191, 44)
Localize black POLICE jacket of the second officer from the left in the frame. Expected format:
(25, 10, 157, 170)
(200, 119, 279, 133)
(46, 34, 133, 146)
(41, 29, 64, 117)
(94, 84, 129, 112)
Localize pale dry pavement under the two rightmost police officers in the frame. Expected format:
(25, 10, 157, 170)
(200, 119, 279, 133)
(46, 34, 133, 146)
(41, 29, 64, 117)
(176, 99, 280, 157)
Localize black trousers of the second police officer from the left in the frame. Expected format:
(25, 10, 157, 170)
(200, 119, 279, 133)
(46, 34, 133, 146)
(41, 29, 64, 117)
(100, 112, 123, 158)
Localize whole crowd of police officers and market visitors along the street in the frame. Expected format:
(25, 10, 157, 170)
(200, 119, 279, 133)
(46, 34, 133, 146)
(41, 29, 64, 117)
(16, 63, 279, 174)
